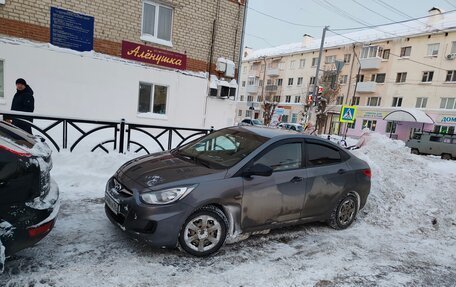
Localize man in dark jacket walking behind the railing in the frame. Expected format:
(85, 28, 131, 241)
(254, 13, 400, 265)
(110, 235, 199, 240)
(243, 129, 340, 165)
(11, 79, 35, 134)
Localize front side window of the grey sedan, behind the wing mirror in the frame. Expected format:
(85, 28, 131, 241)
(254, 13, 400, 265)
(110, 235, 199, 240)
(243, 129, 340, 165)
(255, 143, 302, 171)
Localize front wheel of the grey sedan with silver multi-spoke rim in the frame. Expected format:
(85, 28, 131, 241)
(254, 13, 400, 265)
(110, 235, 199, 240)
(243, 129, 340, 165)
(179, 206, 228, 257)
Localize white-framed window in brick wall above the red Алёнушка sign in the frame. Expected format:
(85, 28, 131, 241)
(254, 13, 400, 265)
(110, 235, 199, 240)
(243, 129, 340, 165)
(141, 1, 173, 46)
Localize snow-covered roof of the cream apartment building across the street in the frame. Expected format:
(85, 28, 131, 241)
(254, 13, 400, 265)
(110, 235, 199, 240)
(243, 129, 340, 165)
(243, 8, 456, 61)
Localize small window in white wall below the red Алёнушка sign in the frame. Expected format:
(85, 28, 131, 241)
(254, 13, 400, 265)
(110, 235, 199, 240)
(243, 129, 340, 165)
(138, 83, 168, 115)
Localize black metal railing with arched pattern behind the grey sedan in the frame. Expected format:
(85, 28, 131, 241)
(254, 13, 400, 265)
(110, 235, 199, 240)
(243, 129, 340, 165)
(0, 111, 213, 153)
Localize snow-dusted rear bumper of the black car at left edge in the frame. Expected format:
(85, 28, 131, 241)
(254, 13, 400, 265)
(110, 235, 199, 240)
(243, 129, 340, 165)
(0, 180, 60, 256)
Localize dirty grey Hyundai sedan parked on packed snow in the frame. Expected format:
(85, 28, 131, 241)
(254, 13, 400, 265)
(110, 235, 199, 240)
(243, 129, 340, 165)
(105, 126, 371, 256)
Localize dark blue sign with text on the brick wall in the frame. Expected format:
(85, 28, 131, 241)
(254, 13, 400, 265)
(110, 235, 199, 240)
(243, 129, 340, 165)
(51, 7, 94, 52)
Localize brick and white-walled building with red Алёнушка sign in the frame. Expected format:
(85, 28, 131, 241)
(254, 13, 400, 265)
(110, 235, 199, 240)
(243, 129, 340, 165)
(0, 0, 245, 127)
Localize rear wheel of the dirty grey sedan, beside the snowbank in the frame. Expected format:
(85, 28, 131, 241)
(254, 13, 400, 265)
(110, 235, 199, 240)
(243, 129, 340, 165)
(329, 194, 358, 229)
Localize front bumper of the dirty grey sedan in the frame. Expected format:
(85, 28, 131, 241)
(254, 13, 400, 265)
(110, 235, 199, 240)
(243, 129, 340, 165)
(105, 178, 192, 248)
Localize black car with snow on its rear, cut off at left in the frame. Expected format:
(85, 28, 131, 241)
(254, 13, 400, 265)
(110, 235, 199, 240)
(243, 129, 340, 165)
(0, 122, 60, 255)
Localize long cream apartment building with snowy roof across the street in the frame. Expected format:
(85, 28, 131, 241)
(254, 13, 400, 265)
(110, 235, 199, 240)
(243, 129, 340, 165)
(237, 8, 456, 139)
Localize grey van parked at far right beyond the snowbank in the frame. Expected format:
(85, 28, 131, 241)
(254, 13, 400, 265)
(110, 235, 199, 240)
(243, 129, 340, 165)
(406, 132, 456, 159)
